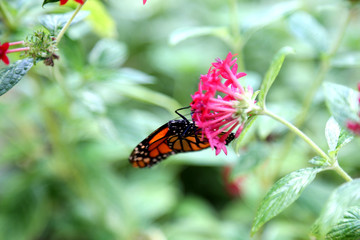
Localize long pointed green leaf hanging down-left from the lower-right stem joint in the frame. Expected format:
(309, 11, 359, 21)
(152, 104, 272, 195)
(251, 168, 322, 235)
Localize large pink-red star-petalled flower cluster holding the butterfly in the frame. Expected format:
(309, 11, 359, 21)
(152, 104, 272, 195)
(190, 53, 258, 155)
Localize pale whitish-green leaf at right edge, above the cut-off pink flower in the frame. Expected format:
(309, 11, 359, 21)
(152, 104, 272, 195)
(324, 83, 360, 128)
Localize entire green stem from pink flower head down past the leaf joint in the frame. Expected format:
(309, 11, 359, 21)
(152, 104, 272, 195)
(261, 109, 352, 182)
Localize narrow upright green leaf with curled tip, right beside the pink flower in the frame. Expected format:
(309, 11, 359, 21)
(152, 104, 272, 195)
(258, 47, 294, 107)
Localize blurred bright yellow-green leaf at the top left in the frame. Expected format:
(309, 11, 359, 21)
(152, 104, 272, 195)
(83, 1, 117, 38)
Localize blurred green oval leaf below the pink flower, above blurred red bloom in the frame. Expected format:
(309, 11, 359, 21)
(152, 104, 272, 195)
(231, 142, 269, 177)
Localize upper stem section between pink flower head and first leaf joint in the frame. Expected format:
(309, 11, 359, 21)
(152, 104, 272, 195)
(263, 110, 332, 162)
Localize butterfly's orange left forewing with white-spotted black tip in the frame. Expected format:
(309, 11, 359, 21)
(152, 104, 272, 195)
(129, 123, 175, 168)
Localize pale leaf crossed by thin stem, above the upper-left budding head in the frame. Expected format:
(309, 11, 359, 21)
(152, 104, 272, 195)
(39, 11, 89, 36)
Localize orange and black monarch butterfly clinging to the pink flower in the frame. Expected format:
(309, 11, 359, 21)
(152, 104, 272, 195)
(129, 109, 235, 168)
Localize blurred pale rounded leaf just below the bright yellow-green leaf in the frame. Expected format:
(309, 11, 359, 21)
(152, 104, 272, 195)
(89, 39, 127, 68)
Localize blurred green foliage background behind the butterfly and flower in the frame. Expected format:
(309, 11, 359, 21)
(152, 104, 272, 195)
(0, 0, 360, 240)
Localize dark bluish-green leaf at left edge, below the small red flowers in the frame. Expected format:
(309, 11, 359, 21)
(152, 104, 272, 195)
(0, 58, 33, 96)
